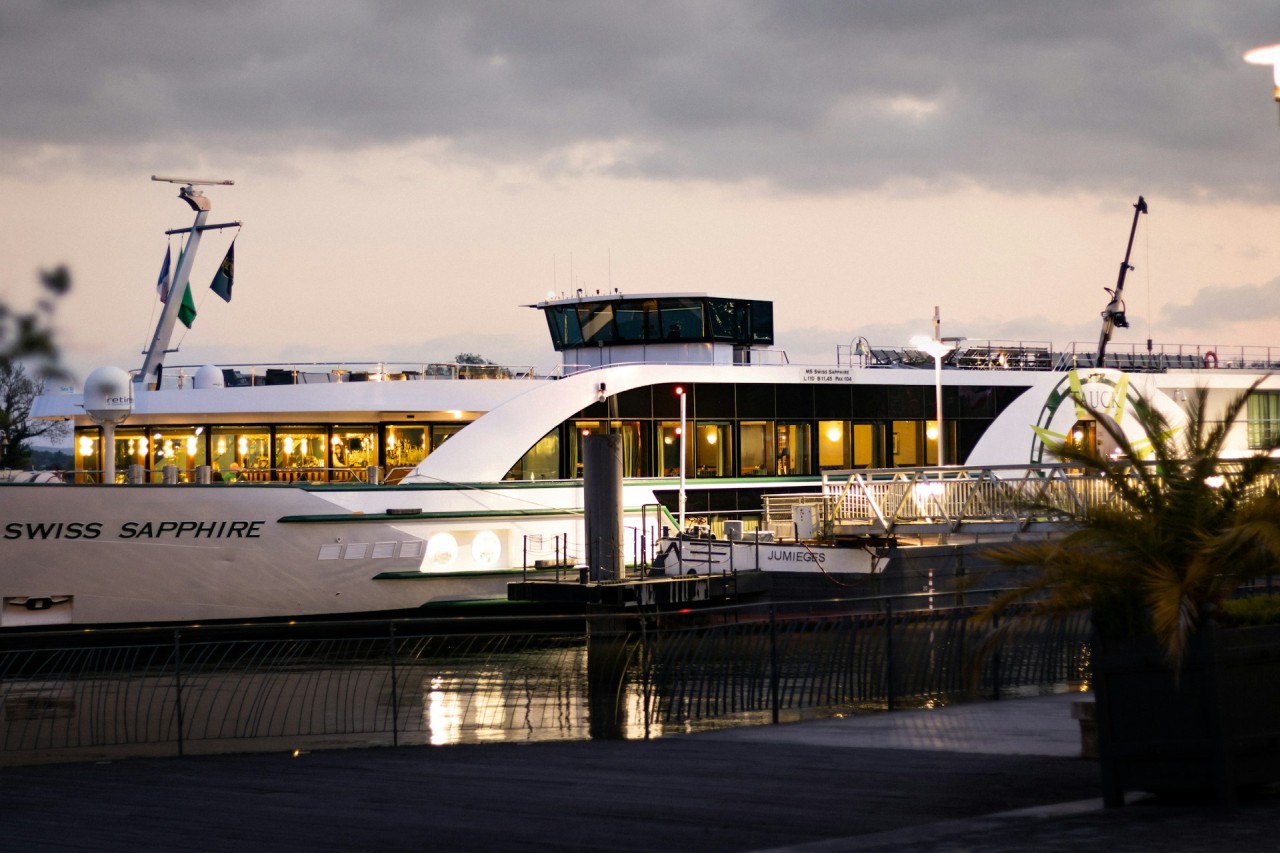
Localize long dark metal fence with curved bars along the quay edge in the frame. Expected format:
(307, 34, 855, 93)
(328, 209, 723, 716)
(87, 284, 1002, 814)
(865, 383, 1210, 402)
(0, 599, 1088, 763)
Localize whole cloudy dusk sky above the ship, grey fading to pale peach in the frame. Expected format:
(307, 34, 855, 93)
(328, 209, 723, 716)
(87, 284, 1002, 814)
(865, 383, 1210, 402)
(0, 0, 1280, 375)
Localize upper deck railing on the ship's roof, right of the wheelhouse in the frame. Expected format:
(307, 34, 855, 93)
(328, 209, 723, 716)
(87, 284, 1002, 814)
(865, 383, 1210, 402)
(836, 341, 1280, 373)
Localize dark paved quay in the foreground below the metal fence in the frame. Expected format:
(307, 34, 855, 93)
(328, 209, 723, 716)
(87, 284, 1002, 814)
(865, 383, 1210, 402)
(0, 693, 1280, 853)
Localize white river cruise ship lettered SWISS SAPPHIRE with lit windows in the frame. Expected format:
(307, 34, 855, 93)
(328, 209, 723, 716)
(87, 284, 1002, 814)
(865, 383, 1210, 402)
(0, 182, 1280, 629)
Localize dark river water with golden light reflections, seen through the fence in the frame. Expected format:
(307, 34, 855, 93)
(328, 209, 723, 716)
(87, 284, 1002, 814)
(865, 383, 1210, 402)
(0, 614, 1087, 763)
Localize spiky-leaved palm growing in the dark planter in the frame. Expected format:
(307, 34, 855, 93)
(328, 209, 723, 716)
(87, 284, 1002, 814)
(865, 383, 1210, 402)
(987, 380, 1280, 667)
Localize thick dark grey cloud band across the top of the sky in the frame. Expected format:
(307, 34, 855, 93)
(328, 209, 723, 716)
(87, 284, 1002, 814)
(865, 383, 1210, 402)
(0, 0, 1280, 197)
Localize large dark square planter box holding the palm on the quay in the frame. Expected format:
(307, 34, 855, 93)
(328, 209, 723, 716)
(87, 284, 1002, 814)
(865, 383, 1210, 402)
(1093, 624, 1280, 808)
